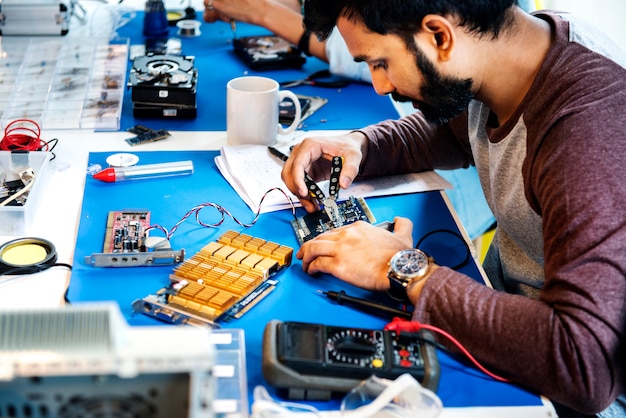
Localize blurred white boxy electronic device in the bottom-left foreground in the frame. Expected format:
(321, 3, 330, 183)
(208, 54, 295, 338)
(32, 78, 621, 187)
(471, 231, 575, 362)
(0, 303, 220, 418)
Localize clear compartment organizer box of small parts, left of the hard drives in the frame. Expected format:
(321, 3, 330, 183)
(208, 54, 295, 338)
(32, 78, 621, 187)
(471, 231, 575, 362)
(0, 37, 130, 131)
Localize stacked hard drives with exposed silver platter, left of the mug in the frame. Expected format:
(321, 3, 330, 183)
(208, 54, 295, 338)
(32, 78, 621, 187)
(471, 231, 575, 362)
(128, 54, 198, 118)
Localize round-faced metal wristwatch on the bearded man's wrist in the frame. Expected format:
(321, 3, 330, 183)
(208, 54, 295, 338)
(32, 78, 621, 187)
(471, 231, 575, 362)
(387, 248, 434, 301)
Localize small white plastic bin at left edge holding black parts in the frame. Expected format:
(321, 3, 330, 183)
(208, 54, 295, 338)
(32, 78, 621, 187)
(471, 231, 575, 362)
(0, 151, 53, 235)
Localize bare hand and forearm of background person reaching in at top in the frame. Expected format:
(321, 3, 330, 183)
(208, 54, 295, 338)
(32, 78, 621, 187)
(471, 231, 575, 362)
(204, 0, 328, 61)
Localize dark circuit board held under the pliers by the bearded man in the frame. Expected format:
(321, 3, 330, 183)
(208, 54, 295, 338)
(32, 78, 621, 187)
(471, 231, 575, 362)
(291, 196, 376, 245)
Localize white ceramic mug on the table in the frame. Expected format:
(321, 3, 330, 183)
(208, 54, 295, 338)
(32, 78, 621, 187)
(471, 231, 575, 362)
(226, 76, 302, 145)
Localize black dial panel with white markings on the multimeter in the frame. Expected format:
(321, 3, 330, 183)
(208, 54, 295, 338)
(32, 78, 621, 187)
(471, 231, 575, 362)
(326, 327, 384, 367)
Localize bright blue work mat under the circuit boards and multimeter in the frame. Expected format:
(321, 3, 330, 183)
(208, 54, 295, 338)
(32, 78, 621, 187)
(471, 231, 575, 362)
(68, 151, 541, 409)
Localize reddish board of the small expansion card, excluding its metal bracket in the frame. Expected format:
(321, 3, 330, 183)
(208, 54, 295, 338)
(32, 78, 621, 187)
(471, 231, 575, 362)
(102, 211, 150, 253)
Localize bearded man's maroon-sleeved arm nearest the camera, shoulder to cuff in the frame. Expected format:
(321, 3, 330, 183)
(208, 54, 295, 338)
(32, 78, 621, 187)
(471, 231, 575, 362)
(413, 75, 626, 414)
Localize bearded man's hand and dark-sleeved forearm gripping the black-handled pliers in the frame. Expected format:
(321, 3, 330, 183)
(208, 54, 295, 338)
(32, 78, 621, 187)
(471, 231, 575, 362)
(282, 113, 473, 212)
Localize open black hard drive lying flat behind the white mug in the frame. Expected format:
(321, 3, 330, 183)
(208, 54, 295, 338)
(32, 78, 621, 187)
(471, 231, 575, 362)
(233, 35, 306, 70)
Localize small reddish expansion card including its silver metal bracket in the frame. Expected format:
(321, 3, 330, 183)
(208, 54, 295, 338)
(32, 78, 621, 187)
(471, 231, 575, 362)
(85, 210, 185, 267)
